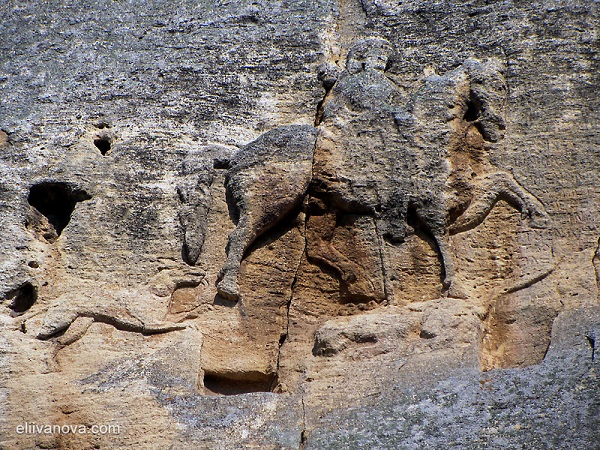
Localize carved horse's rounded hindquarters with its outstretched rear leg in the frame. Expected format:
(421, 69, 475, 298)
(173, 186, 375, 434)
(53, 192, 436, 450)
(217, 125, 316, 300)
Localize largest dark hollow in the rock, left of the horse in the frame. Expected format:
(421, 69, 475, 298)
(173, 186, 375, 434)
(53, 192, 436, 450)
(27, 182, 92, 235)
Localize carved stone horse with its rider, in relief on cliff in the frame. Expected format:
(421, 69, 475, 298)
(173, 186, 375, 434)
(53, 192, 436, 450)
(213, 39, 548, 301)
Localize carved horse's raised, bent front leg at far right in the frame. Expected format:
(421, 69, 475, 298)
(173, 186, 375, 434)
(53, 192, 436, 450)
(450, 172, 550, 234)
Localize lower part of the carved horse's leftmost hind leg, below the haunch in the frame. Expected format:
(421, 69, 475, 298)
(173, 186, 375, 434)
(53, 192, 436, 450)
(217, 214, 257, 300)
